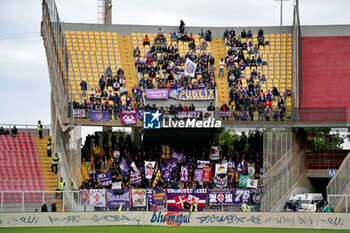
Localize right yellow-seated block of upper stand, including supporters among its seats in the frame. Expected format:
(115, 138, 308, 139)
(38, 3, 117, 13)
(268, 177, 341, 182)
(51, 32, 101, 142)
(223, 29, 292, 120)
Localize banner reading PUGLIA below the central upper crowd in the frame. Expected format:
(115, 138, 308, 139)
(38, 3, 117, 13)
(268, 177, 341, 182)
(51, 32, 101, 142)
(169, 89, 215, 100)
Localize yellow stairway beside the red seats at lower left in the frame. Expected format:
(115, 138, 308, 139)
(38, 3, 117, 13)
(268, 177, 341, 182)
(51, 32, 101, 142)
(34, 136, 62, 211)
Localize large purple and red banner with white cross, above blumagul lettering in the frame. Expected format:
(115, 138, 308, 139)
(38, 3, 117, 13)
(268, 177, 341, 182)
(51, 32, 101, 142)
(166, 189, 207, 211)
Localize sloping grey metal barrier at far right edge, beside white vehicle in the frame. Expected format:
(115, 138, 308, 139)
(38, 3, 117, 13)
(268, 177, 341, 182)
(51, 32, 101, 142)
(327, 153, 350, 208)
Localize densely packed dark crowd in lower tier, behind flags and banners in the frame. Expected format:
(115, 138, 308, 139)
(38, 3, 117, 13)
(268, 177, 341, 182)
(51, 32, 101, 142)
(81, 131, 263, 189)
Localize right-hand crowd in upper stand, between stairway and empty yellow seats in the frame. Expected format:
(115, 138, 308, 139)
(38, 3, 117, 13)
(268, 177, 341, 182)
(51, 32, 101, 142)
(219, 28, 291, 121)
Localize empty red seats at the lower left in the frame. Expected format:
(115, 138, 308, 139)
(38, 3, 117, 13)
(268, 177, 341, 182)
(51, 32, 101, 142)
(0, 132, 46, 202)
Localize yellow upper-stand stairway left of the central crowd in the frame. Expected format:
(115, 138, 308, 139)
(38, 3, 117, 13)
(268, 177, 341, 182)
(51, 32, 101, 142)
(119, 36, 138, 102)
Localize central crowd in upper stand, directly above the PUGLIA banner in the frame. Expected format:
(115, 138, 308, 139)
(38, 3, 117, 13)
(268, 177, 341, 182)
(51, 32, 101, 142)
(133, 24, 216, 89)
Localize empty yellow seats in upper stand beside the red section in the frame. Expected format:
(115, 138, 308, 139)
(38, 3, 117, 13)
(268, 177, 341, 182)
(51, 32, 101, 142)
(226, 33, 292, 112)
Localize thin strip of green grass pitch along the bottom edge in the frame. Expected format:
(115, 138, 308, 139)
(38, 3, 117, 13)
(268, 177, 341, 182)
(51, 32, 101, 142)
(0, 226, 349, 233)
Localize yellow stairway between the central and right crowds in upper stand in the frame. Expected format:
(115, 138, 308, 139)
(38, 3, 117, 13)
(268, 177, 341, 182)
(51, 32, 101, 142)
(212, 38, 230, 107)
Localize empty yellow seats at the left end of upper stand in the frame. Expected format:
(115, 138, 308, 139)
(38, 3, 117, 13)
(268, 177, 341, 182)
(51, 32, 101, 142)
(64, 31, 121, 103)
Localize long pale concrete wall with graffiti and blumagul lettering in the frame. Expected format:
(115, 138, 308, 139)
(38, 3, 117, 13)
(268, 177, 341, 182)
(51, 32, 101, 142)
(0, 212, 350, 230)
